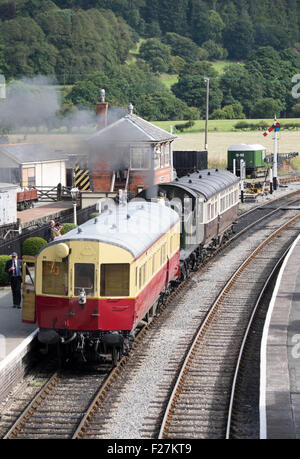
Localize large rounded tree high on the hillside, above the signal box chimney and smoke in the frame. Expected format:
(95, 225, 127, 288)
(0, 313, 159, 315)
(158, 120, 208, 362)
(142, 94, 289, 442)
(37, 9, 136, 83)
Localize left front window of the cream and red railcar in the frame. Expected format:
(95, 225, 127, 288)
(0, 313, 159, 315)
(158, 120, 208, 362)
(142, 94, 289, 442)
(42, 261, 68, 295)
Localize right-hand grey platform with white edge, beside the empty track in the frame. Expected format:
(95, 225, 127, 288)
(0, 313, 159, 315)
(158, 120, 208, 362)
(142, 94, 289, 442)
(260, 236, 300, 439)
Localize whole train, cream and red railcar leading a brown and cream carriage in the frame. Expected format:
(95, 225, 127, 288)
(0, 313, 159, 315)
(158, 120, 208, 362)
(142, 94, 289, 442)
(22, 169, 239, 364)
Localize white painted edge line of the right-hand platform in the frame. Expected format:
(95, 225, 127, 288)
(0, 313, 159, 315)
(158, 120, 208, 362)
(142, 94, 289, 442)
(259, 235, 300, 439)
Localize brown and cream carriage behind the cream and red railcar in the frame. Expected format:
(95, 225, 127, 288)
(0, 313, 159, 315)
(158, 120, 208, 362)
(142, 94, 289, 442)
(138, 169, 239, 276)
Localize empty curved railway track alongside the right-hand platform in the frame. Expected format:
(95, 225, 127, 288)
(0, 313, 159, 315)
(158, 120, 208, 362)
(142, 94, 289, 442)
(159, 215, 300, 438)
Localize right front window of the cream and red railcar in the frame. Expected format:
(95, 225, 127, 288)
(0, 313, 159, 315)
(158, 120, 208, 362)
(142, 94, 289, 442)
(100, 263, 129, 296)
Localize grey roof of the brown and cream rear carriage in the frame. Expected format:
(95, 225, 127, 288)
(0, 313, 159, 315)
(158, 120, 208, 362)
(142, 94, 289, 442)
(170, 169, 239, 199)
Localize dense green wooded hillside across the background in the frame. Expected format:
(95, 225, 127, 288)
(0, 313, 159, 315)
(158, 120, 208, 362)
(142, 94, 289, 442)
(0, 0, 300, 120)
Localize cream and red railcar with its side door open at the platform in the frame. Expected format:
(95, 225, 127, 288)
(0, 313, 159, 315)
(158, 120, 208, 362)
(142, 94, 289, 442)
(23, 202, 180, 360)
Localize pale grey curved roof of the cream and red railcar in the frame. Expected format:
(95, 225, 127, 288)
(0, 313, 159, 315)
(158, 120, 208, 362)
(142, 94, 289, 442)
(47, 201, 179, 258)
